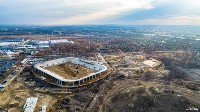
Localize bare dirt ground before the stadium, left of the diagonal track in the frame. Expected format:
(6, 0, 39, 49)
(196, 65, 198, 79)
(0, 63, 111, 112)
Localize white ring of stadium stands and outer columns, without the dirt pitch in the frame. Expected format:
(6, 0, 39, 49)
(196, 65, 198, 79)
(34, 57, 107, 87)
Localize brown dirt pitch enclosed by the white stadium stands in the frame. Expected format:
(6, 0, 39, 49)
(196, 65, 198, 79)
(46, 62, 96, 79)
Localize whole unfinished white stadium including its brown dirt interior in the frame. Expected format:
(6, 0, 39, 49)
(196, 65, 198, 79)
(34, 57, 107, 87)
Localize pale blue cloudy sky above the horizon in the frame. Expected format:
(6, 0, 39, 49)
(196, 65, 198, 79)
(0, 0, 200, 25)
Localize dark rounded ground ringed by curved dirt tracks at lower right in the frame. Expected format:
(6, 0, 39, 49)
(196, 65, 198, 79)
(100, 80, 200, 112)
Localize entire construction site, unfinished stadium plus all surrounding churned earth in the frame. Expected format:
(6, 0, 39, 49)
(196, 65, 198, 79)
(0, 34, 200, 112)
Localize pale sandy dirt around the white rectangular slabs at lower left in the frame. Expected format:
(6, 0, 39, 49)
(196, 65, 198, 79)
(0, 72, 68, 112)
